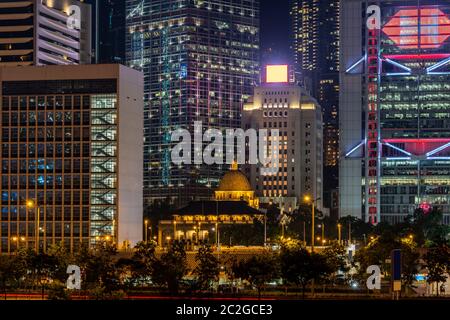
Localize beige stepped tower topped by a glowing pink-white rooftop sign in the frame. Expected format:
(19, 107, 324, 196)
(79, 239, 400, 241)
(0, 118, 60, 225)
(242, 66, 323, 211)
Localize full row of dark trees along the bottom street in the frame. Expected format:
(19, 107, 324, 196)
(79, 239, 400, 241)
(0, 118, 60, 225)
(0, 238, 450, 299)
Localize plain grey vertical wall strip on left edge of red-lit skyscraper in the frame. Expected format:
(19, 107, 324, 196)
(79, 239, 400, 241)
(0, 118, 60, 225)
(339, 0, 365, 218)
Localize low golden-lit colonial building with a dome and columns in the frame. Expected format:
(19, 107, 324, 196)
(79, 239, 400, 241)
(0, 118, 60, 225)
(158, 163, 264, 246)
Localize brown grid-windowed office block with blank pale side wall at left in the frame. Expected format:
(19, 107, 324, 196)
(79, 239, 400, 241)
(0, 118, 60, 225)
(0, 65, 143, 254)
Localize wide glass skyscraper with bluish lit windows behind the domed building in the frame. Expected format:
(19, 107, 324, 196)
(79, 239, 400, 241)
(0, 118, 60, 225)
(126, 0, 259, 205)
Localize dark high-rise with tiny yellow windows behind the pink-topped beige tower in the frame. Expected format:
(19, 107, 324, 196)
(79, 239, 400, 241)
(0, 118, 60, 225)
(291, 0, 340, 212)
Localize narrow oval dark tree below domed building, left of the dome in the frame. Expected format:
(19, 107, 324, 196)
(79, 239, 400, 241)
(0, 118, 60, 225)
(194, 245, 220, 290)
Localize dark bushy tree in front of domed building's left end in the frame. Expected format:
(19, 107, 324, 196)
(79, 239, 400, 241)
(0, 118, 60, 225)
(152, 242, 188, 294)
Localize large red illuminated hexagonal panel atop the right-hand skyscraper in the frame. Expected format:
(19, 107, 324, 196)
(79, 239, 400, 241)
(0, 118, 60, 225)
(383, 8, 450, 49)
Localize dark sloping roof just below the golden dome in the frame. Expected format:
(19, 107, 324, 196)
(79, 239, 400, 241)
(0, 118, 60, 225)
(174, 200, 263, 216)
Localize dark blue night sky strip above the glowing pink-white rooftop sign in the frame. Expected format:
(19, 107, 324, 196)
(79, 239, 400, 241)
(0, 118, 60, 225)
(260, 0, 291, 64)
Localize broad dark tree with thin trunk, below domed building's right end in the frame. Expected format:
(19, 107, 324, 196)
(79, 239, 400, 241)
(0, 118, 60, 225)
(232, 252, 279, 298)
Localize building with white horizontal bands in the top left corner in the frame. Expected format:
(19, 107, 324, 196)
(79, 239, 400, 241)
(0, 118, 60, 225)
(0, 0, 92, 66)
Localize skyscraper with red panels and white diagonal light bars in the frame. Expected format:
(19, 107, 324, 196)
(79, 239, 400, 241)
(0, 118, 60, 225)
(339, 0, 450, 224)
